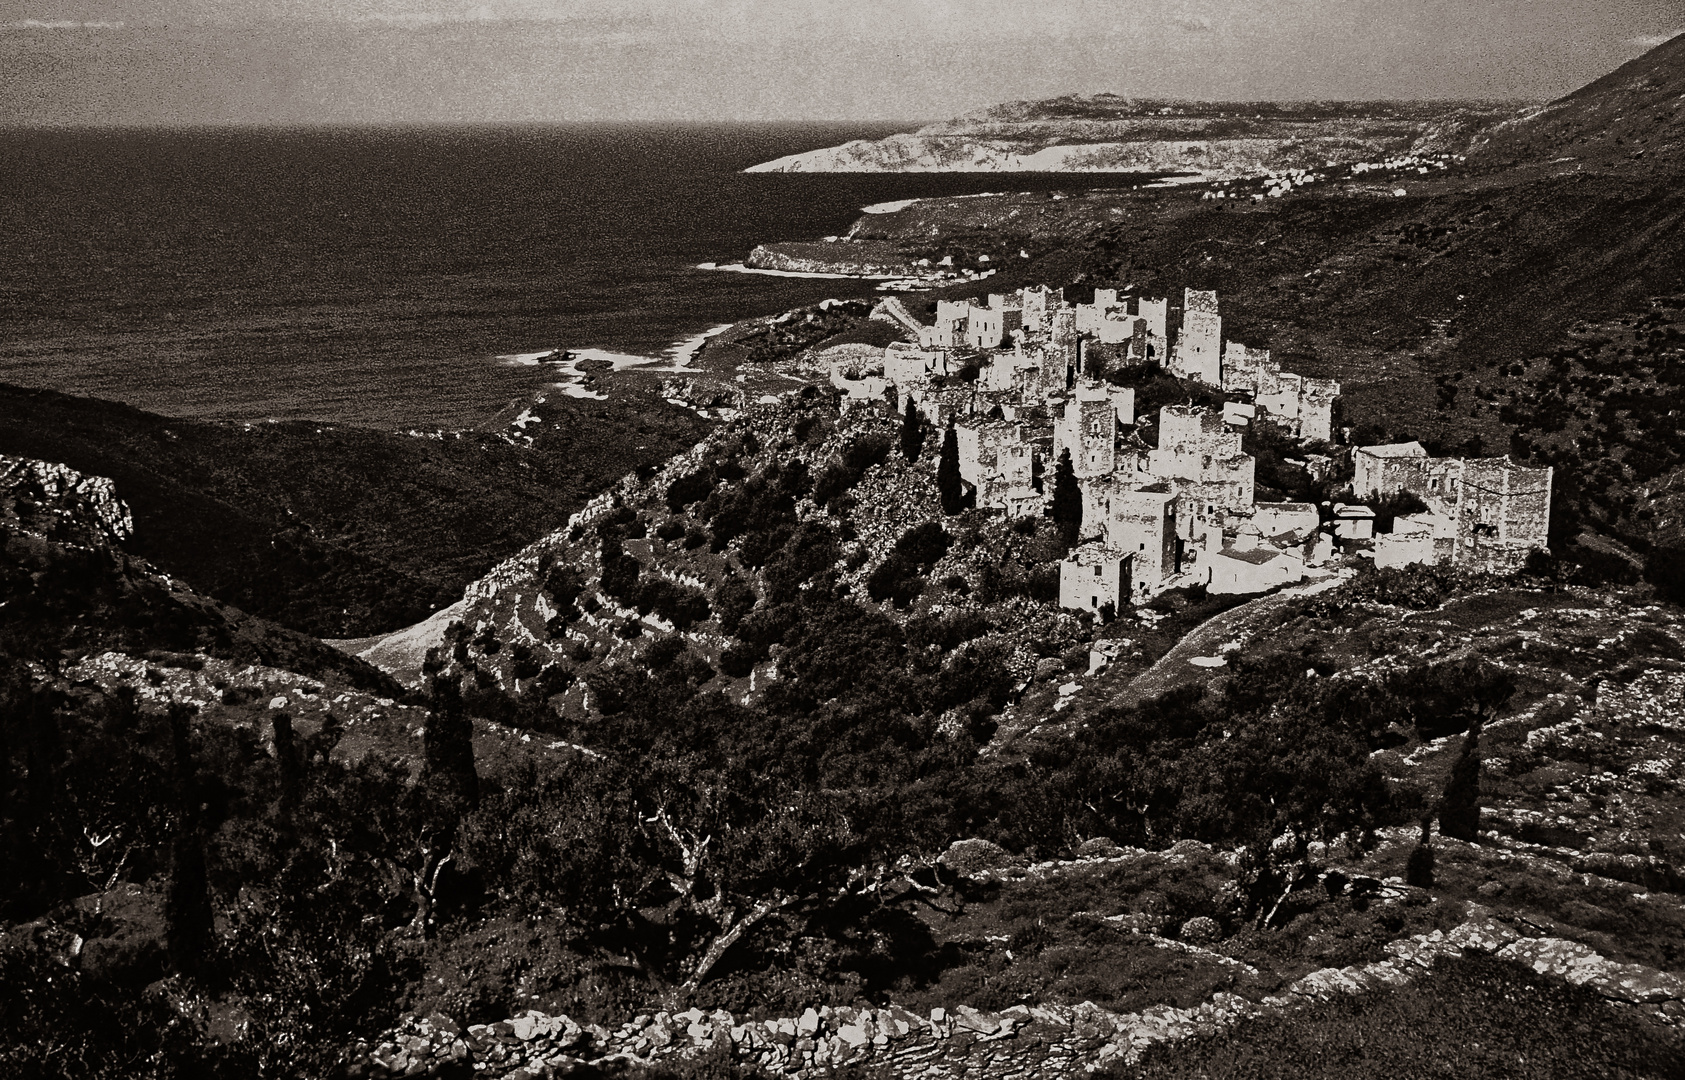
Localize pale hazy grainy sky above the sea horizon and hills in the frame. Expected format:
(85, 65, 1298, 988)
(0, 0, 1685, 123)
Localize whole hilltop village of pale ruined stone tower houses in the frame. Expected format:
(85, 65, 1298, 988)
(819, 286, 1552, 610)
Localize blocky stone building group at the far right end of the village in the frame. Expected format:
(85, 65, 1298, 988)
(1351, 443, 1554, 573)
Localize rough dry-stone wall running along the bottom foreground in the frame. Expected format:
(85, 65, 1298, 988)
(350, 908, 1685, 1080)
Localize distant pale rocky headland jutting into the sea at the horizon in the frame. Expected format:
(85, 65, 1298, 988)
(748, 94, 1515, 179)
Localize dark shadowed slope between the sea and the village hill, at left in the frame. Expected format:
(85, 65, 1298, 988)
(0, 386, 708, 637)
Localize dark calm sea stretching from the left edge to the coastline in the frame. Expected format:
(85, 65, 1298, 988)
(0, 125, 1145, 426)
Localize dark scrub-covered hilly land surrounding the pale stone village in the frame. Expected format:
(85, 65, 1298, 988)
(16, 33, 1685, 1080)
